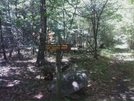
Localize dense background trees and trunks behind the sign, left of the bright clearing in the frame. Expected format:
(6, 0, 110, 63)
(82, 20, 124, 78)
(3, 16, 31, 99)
(1, 0, 121, 60)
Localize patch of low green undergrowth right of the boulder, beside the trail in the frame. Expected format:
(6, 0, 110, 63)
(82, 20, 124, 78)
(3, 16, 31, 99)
(71, 54, 110, 82)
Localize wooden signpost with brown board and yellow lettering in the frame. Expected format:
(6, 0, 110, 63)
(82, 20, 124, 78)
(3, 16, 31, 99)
(45, 37, 71, 100)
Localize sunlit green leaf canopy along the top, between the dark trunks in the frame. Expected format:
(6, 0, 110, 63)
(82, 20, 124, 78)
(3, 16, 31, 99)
(0, 0, 133, 52)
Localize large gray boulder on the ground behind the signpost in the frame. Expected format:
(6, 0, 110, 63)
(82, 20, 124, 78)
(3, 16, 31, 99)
(48, 70, 88, 96)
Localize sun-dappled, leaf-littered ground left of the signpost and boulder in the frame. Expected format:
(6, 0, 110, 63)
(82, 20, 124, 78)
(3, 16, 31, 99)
(0, 57, 52, 100)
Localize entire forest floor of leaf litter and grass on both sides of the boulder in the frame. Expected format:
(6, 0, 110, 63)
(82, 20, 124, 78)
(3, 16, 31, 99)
(0, 44, 134, 101)
